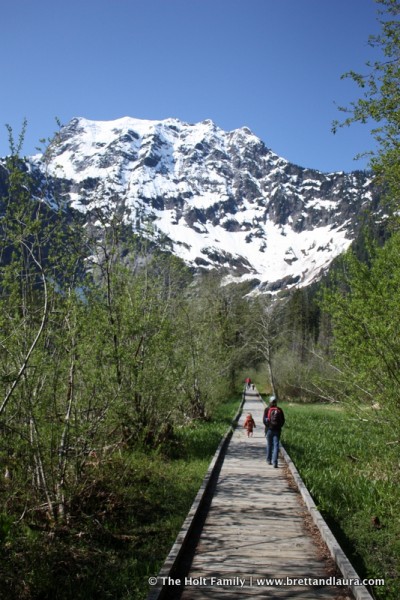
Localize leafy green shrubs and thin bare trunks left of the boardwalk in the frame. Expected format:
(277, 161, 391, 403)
(0, 151, 260, 523)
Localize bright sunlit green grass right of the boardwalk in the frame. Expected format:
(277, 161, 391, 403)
(282, 403, 400, 600)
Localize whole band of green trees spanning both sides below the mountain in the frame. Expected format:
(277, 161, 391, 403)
(0, 139, 400, 523)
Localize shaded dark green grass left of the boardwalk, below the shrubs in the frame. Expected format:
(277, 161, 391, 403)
(0, 397, 240, 600)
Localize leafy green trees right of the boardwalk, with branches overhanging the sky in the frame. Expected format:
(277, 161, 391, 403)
(272, 0, 400, 442)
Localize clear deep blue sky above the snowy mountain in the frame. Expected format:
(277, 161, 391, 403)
(0, 0, 380, 171)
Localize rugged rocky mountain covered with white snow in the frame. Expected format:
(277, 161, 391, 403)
(31, 117, 376, 290)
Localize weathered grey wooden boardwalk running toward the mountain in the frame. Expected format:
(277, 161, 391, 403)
(177, 392, 353, 600)
